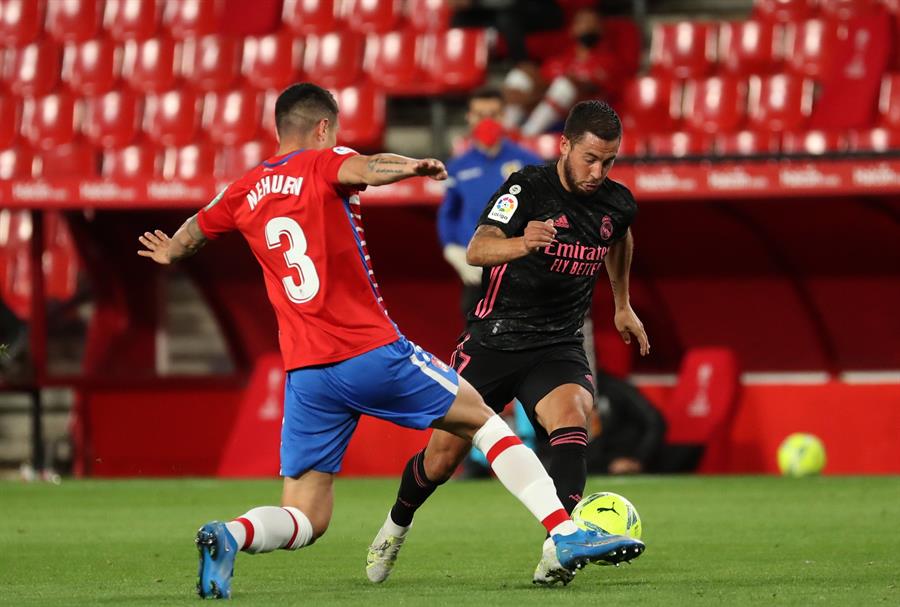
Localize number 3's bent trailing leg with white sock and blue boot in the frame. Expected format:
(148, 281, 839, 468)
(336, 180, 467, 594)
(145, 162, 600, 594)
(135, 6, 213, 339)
(197, 470, 334, 599)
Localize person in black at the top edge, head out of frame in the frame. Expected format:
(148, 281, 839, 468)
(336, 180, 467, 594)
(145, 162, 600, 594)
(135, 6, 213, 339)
(447, 0, 564, 63)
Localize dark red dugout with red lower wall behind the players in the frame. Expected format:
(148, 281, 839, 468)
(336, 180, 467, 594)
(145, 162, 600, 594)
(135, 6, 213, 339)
(7, 176, 900, 476)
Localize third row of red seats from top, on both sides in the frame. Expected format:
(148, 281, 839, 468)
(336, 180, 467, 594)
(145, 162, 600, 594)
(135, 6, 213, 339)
(7, 74, 900, 157)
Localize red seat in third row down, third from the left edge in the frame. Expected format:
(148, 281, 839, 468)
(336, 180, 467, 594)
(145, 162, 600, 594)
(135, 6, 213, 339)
(82, 88, 141, 148)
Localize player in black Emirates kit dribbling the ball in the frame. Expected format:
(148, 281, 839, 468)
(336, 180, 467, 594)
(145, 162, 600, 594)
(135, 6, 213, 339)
(366, 101, 650, 584)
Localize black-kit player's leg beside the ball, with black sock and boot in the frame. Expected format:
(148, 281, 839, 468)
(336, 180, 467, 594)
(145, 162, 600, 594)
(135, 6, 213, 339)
(532, 384, 593, 585)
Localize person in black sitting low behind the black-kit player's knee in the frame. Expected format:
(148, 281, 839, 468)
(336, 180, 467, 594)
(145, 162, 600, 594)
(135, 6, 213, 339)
(587, 371, 666, 474)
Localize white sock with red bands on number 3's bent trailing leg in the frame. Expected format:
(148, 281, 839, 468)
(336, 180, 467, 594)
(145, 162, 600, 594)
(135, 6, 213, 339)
(225, 506, 312, 554)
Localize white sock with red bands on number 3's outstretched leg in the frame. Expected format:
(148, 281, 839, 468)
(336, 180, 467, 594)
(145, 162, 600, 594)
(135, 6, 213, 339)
(472, 415, 577, 535)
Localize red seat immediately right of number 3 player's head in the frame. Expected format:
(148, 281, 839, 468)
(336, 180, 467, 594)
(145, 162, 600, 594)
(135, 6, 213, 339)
(334, 83, 385, 150)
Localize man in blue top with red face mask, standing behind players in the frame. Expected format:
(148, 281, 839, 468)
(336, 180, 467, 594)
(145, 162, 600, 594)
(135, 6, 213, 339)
(437, 87, 542, 316)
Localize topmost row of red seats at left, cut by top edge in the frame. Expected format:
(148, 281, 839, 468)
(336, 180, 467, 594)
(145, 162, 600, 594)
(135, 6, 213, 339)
(0, 0, 449, 46)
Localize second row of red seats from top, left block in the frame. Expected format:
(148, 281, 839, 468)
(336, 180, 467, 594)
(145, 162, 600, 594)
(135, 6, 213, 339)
(3, 29, 487, 96)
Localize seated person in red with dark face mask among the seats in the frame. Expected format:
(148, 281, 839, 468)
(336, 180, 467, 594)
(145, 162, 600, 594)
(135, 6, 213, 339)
(503, 9, 641, 137)
